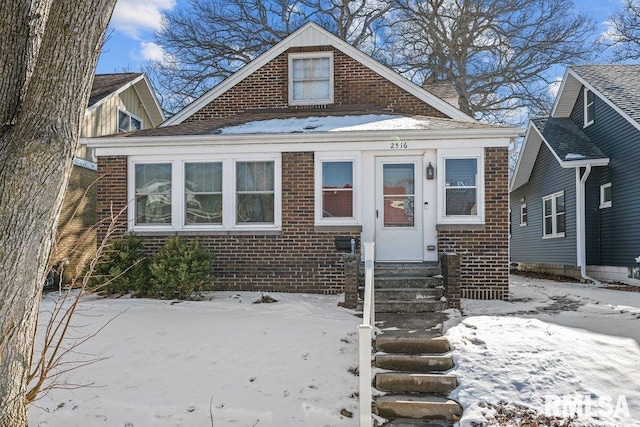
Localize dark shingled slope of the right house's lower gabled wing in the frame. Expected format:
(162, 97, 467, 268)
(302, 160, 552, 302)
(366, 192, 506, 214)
(532, 118, 607, 162)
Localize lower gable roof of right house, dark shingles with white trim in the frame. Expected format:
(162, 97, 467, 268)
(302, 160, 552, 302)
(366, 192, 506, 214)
(510, 117, 609, 191)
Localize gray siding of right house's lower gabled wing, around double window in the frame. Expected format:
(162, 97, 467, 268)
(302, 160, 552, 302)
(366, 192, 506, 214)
(510, 143, 577, 265)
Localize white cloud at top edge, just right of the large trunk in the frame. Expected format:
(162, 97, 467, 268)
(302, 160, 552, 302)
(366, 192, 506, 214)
(111, 0, 176, 39)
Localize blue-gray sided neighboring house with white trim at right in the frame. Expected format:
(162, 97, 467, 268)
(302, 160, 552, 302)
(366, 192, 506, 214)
(510, 65, 640, 280)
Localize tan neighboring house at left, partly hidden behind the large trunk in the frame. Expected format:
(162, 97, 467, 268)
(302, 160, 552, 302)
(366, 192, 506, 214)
(52, 73, 164, 281)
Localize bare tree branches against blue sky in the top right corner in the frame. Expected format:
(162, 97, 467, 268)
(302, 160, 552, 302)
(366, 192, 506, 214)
(600, 0, 640, 61)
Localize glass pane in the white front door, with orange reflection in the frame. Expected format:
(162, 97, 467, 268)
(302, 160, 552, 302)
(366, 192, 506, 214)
(382, 164, 415, 227)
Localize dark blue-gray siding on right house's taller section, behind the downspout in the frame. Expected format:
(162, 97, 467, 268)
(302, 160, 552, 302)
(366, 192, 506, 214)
(571, 87, 640, 267)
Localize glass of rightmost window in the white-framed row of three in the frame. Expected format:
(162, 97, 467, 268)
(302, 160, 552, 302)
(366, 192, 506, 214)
(236, 162, 275, 224)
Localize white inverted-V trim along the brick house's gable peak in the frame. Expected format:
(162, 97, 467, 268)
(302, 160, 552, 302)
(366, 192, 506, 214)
(161, 22, 475, 126)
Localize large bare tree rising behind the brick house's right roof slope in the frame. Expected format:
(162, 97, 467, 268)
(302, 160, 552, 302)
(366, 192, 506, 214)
(394, 0, 595, 122)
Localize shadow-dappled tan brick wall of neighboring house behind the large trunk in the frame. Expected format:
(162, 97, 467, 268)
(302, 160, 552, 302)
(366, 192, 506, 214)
(52, 165, 97, 283)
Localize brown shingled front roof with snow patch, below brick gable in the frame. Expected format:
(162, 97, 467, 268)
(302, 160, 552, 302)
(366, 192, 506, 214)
(112, 108, 504, 138)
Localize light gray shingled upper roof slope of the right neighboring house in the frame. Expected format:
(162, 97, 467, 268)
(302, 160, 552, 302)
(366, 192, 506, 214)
(571, 65, 640, 123)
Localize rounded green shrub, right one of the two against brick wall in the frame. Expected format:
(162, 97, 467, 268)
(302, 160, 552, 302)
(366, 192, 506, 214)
(149, 236, 213, 299)
